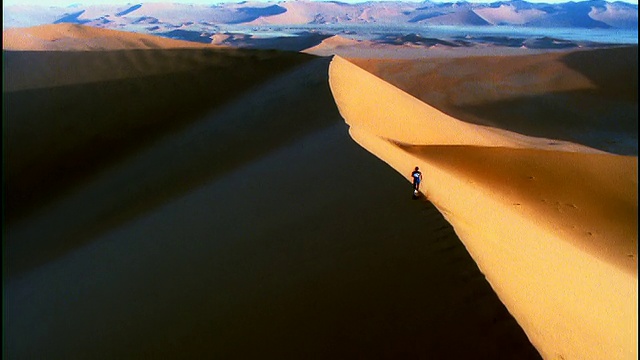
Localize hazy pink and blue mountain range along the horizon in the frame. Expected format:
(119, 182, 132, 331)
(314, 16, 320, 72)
(3, 0, 638, 33)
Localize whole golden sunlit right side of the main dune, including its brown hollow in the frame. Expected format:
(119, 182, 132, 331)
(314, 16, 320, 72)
(329, 56, 638, 359)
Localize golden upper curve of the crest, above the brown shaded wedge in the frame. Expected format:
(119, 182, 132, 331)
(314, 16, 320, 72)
(329, 56, 601, 153)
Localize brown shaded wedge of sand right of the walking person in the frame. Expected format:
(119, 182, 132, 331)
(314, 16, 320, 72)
(399, 144, 638, 274)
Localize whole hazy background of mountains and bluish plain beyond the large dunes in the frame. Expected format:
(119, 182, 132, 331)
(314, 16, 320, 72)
(3, 0, 638, 52)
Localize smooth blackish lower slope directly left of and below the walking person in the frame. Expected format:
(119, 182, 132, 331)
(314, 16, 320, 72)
(6, 123, 540, 360)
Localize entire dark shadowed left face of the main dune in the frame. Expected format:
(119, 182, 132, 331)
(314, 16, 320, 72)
(3, 23, 539, 359)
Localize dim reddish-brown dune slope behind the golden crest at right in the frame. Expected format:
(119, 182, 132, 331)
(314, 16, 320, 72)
(350, 47, 638, 155)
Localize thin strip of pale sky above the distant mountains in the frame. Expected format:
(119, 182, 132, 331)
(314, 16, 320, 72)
(2, 0, 638, 6)
